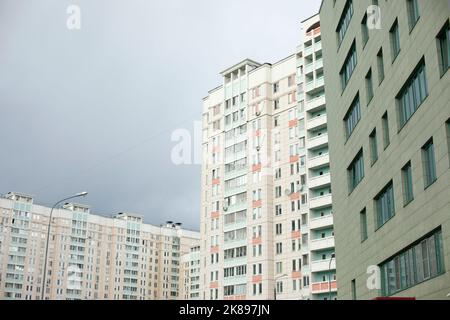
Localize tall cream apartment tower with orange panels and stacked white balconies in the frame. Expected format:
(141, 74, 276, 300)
(200, 16, 336, 300)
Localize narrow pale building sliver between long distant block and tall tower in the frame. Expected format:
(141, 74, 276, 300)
(180, 245, 201, 300)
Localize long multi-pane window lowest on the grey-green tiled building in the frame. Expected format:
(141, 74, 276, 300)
(380, 228, 445, 296)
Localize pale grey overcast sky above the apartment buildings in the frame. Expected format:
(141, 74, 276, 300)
(0, 0, 321, 230)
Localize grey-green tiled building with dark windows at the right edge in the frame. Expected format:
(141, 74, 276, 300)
(320, 0, 450, 299)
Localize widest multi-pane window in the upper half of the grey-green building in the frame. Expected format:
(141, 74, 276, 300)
(397, 59, 428, 128)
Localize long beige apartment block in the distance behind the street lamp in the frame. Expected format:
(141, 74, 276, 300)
(0, 193, 199, 300)
